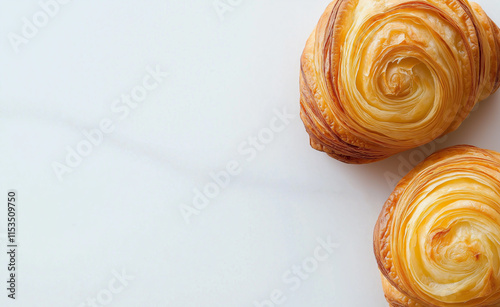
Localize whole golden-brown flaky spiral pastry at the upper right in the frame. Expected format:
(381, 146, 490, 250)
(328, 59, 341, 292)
(300, 0, 500, 163)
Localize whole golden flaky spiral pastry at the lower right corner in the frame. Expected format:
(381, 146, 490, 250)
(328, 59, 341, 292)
(374, 146, 500, 307)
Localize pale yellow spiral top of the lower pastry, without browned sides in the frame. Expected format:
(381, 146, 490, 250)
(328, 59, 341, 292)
(397, 173, 500, 304)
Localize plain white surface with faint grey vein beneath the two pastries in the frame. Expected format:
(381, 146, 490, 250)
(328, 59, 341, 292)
(0, 0, 500, 307)
